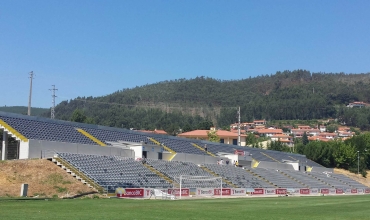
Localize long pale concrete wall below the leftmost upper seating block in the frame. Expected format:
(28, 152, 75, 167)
(28, 140, 135, 159)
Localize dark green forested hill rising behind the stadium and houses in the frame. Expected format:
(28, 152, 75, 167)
(49, 70, 370, 130)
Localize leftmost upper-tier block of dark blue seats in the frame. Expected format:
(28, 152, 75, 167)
(0, 115, 96, 145)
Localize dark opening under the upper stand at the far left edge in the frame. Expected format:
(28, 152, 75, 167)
(0, 129, 20, 160)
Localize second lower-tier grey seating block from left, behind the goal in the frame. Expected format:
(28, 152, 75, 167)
(147, 159, 223, 188)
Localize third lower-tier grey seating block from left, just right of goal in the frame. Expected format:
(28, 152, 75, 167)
(204, 164, 271, 188)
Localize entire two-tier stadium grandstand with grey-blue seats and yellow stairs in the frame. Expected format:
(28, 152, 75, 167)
(0, 112, 370, 197)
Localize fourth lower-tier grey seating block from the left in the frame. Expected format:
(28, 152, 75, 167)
(251, 168, 304, 188)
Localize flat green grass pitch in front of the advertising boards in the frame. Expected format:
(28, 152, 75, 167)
(0, 195, 370, 220)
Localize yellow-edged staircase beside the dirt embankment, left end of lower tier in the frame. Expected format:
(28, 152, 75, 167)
(52, 157, 107, 194)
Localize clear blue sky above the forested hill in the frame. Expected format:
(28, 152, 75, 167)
(0, 0, 370, 107)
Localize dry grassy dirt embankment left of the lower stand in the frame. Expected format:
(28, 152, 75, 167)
(0, 159, 94, 198)
